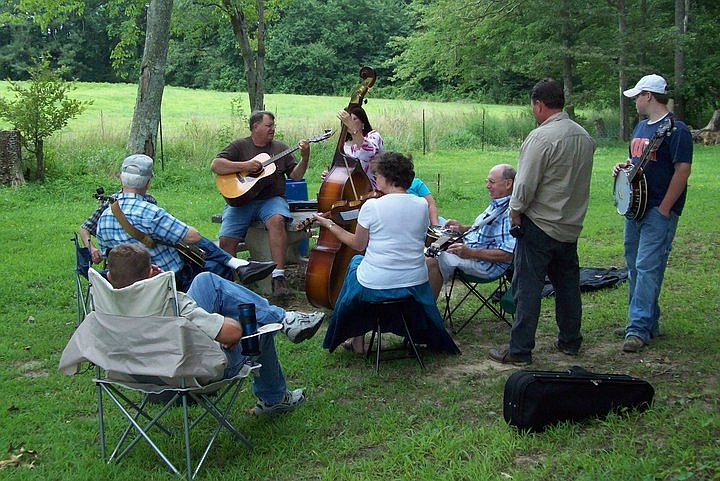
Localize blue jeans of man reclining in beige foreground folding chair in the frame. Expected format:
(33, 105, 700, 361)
(187, 272, 287, 404)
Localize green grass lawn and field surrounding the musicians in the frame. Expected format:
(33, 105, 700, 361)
(0, 84, 720, 481)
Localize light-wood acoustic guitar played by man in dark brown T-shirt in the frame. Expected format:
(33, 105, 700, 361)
(215, 129, 335, 207)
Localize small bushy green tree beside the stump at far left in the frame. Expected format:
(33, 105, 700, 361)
(0, 60, 91, 179)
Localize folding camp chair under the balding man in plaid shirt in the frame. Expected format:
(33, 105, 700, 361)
(443, 269, 515, 334)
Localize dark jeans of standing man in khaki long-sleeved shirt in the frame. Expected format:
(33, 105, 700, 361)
(509, 216, 582, 357)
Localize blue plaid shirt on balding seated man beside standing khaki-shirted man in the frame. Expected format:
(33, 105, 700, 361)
(464, 195, 515, 275)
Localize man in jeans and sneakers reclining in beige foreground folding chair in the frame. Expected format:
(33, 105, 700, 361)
(100, 244, 322, 415)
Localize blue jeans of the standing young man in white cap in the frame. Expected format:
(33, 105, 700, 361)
(625, 207, 678, 343)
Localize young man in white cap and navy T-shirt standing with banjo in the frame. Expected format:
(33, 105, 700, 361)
(613, 74, 692, 352)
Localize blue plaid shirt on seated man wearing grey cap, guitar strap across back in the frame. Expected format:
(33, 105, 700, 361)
(97, 192, 190, 272)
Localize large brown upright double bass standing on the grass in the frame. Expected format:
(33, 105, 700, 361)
(305, 67, 376, 309)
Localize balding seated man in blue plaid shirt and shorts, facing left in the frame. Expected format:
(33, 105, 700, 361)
(425, 164, 515, 329)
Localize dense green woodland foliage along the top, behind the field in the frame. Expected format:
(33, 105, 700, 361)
(0, 0, 720, 125)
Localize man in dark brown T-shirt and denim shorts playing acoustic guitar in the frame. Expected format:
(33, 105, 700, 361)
(211, 111, 310, 302)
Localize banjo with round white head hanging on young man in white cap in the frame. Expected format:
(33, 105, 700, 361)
(613, 117, 673, 220)
